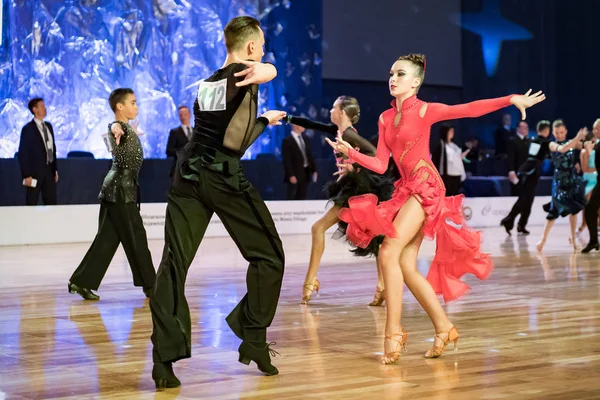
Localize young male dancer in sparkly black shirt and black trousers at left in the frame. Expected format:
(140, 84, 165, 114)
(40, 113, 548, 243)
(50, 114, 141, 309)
(68, 88, 156, 300)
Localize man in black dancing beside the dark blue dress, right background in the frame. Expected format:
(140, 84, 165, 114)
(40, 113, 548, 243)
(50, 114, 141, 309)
(500, 121, 550, 235)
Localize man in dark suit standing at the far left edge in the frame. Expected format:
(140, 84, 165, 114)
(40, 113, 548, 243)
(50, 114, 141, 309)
(18, 97, 58, 206)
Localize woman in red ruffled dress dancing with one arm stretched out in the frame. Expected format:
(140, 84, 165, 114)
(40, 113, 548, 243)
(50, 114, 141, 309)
(328, 54, 545, 364)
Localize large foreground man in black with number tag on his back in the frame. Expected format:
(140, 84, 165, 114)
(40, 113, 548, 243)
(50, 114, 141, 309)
(150, 16, 285, 389)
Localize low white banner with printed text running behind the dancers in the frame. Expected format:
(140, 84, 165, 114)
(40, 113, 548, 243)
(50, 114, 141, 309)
(0, 197, 568, 246)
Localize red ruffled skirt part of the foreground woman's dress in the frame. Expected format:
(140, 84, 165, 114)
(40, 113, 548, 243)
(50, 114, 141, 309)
(339, 168, 493, 302)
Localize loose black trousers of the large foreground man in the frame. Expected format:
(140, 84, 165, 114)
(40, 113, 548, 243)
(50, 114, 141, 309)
(150, 153, 284, 362)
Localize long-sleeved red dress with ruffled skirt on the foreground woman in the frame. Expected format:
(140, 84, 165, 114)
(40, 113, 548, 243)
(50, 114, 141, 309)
(339, 96, 511, 302)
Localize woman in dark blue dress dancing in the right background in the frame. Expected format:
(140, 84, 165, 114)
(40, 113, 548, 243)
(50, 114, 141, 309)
(537, 119, 587, 251)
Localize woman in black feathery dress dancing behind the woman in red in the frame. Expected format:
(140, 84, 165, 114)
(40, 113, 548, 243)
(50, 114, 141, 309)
(287, 96, 394, 306)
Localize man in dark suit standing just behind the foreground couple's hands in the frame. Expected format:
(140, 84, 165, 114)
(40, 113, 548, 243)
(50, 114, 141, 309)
(281, 125, 317, 200)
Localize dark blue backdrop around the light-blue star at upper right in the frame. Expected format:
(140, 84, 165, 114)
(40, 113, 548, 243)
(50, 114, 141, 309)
(462, 0, 600, 144)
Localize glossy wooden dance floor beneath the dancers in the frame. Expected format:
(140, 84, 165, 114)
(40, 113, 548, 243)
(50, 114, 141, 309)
(0, 226, 600, 400)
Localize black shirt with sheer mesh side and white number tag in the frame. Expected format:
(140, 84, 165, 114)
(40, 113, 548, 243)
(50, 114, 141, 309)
(190, 63, 269, 158)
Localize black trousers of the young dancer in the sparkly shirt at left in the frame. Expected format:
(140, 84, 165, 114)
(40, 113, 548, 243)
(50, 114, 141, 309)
(69, 201, 156, 290)
